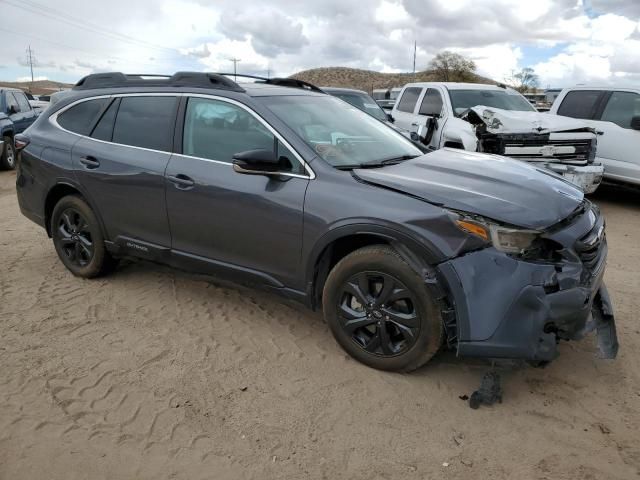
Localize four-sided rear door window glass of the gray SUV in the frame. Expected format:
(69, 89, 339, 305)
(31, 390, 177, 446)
(113, 96, 177, 152)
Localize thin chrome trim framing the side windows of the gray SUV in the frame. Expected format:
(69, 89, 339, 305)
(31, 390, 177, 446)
(48, 92, 316, 180)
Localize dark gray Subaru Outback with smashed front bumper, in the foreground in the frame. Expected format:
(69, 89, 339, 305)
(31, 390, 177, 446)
(17, 72, 617, 371)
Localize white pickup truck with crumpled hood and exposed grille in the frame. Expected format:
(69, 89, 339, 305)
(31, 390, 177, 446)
(391, 82, 604, 193)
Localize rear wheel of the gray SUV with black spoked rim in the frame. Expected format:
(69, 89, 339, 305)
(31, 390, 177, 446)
(51, 195, 115, 278)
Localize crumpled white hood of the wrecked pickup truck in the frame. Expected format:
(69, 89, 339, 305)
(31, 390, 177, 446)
(471, 105, 595, 134)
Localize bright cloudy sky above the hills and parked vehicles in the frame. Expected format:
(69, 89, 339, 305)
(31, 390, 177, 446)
(0, 0, 640, 88)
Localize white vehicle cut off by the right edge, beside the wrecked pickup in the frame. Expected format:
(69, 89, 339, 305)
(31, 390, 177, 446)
(549, 87, 640, 185)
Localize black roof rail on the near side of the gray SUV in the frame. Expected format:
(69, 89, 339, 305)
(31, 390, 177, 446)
(73, 72, 245, 92)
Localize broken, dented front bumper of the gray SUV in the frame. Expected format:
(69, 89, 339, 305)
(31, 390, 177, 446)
(438, 204, 618, 362)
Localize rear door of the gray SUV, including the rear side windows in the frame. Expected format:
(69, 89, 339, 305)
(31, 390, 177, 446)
(57, 94, 178, 251)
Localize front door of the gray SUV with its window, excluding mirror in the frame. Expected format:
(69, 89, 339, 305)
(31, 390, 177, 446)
(166, 97, 309, 286)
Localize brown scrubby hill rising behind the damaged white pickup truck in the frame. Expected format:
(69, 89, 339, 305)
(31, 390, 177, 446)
(291, 67, 496, 93)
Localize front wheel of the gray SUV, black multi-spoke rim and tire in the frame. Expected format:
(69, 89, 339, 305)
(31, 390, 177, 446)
(322, 245, 444, 372)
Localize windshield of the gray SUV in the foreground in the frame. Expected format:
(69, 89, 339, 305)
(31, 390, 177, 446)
(260, 95, 422, 167)
